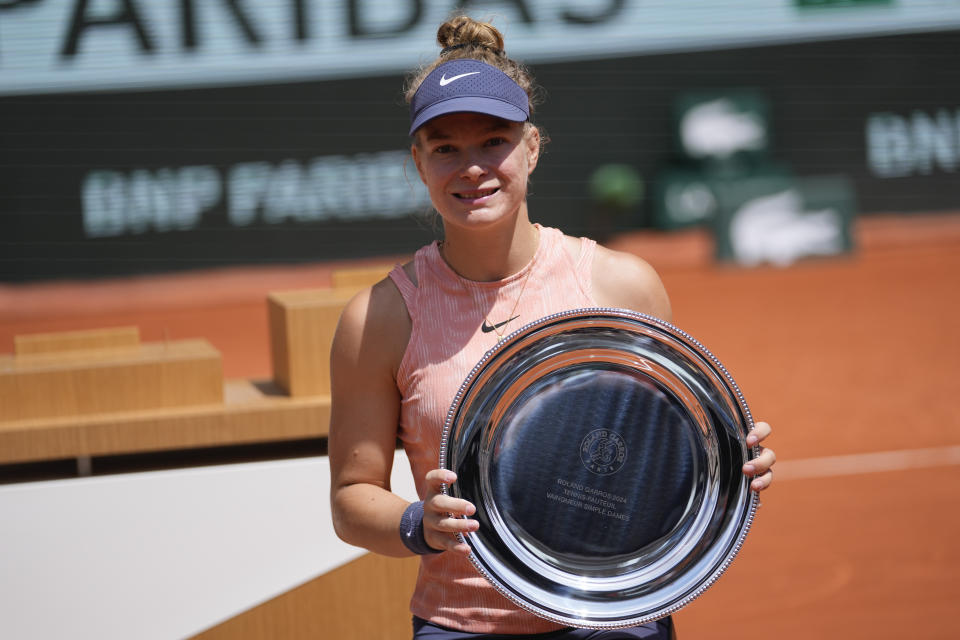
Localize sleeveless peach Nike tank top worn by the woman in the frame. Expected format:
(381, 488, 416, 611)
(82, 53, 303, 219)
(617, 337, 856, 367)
(390, 227, 596, 634)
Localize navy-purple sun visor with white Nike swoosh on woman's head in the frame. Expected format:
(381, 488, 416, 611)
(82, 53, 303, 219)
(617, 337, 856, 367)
(410, 58, 530, 136)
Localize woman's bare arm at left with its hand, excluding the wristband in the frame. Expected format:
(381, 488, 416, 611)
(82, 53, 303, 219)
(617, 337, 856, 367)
(329, 281, 478, 556)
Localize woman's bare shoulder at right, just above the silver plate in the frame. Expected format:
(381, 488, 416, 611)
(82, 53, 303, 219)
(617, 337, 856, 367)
(593, 245, 672, 322)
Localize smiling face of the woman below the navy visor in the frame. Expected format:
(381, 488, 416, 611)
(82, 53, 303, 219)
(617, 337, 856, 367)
(411, 113, 540, 232)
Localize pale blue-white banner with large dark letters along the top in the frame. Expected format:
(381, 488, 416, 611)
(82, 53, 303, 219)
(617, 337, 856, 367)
(0, 0, 960, 95)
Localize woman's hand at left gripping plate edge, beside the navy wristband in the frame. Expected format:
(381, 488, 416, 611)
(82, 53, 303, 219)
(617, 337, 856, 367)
(423, 469, 480, 556)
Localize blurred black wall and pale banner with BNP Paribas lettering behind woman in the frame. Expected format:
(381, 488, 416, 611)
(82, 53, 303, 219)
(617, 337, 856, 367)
(0, 0, 960, 282)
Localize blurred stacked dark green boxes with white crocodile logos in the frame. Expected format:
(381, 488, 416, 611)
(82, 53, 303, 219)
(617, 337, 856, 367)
(651, 89, 856, 265)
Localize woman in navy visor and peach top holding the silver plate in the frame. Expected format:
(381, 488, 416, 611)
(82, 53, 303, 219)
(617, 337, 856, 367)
(329, 16, 775, 640)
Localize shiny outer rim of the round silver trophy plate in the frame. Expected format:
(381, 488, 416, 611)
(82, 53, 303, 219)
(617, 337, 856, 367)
(440, 307, 760, 629)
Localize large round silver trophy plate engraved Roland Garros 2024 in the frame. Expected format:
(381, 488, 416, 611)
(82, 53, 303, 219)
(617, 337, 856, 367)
(440, 309, 758, 629)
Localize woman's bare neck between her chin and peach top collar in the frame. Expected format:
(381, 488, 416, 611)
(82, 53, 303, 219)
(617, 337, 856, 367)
(440, 216, 540, 282)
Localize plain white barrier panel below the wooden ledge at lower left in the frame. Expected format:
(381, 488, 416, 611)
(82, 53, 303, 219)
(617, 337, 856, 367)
(0, 451, 416, 640)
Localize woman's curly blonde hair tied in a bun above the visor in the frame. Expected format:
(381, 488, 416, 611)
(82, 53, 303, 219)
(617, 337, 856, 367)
(404, 15, 542, 122)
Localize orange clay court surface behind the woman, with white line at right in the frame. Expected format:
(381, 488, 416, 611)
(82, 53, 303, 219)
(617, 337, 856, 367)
(0, 214, 960, 640)
